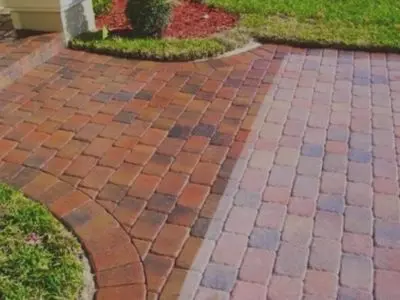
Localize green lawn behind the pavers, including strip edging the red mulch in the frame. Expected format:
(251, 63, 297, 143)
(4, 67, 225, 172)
(70, 0, 400, 60)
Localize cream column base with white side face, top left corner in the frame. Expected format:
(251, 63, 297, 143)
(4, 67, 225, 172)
(4, 0, 95, 40)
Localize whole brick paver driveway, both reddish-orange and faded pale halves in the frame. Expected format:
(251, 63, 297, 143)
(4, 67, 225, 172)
(0, 45, 400, 300)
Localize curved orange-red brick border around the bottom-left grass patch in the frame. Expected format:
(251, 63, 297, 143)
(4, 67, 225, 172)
(0, 162, 146, 300)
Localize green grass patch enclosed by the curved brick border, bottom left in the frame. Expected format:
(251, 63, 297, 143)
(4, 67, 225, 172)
(0, 185, 83, 300)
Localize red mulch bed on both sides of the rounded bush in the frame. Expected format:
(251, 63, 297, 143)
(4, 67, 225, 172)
(96, 0, 238, 39)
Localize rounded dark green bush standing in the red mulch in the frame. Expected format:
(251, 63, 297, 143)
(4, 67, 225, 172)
(125, 0, 172, 38)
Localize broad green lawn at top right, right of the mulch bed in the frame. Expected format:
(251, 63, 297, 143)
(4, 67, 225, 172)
(206, 0, 400, 50)
